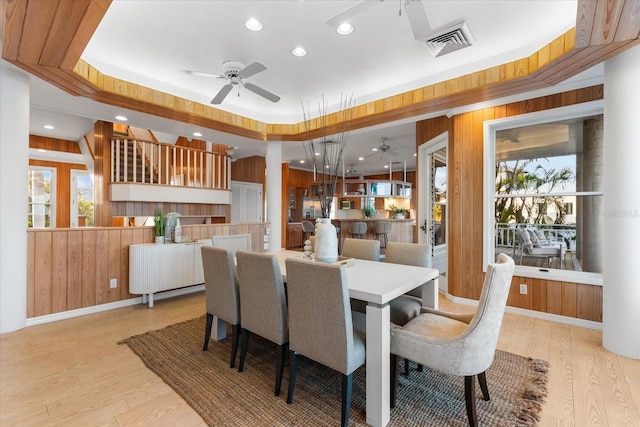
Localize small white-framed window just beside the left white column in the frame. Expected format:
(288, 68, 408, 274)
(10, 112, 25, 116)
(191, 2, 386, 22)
(27, 166, 56, 228)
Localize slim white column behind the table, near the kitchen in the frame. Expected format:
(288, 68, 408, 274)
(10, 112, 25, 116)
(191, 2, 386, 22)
(266, 141, 282, 252)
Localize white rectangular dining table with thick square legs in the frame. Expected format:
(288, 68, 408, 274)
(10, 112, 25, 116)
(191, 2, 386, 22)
(213, 250, 439, 427)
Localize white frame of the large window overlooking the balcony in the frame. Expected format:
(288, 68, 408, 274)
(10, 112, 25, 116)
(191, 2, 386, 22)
(482, 100, 604, 286)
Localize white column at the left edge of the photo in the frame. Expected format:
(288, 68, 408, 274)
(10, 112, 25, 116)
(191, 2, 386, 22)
(0, 67, 29, 333)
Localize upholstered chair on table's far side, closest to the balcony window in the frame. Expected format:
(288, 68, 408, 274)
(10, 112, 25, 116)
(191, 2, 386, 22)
(384, 242, 429, 376)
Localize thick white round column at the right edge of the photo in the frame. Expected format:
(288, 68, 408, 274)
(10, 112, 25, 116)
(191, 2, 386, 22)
(602, 46, 640, 359)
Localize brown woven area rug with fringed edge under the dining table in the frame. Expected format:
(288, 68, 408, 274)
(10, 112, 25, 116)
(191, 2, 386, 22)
(121, 316, 547, 427)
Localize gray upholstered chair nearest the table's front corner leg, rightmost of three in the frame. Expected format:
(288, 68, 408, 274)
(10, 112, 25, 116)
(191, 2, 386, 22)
(285, 258, 366, 426)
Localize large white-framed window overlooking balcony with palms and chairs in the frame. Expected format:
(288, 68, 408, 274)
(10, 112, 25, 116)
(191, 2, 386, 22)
(484, 102, 604, 284)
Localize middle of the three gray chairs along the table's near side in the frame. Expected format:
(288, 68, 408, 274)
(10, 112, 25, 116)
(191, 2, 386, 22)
(236, 251, 289, 396)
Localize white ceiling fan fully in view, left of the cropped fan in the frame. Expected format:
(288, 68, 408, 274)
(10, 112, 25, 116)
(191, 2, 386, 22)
(181, 61, 280, 105)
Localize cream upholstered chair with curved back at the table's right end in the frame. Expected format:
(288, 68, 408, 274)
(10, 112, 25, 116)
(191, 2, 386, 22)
(391, 254, 515, 426)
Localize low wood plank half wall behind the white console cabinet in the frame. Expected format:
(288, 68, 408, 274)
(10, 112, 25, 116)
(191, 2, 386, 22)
(27, 223, 269, 318)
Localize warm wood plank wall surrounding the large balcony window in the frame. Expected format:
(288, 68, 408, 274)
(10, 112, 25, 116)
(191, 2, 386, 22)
(416, 85, 603, 321)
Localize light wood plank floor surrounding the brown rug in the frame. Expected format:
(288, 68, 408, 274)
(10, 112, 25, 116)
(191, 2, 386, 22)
(0, 293, 640, 427)
